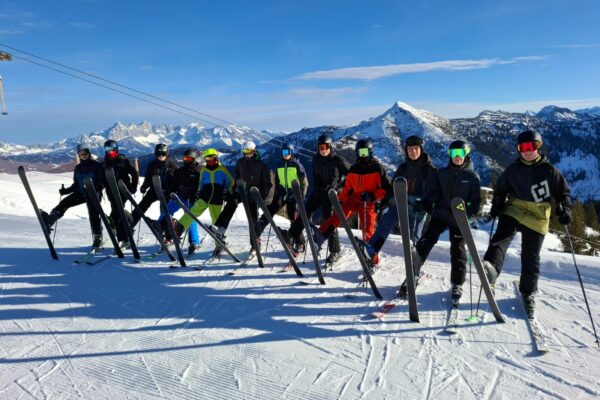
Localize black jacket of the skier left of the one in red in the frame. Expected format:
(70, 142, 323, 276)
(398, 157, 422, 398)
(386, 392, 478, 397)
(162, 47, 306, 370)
(312, 148, 350, 198)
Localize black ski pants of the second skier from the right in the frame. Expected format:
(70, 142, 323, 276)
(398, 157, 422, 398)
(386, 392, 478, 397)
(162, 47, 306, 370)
(415, 217, 467, 285)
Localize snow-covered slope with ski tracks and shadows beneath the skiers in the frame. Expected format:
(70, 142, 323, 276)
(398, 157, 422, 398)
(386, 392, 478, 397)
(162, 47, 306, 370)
(0, 173, 600, 399)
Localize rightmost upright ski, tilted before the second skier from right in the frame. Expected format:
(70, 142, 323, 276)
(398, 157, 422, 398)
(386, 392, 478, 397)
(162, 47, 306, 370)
(451, 197, 505, 322)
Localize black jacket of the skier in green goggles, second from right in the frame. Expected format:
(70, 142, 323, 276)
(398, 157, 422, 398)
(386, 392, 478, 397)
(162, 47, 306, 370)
(425, 156, 481, 226)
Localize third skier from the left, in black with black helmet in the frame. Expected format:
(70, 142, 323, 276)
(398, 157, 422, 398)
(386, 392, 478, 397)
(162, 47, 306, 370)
(131, 143, 177, 229)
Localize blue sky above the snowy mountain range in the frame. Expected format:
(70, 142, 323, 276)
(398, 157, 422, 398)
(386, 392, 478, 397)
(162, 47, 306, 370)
(0, 0, 600, 144)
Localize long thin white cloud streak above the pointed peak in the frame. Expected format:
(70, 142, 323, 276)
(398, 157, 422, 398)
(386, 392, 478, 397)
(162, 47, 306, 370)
(292, 56, 548, 80)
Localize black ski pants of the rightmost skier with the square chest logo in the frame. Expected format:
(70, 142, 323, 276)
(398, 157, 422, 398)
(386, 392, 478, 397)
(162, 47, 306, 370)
(483, 214, 546, 294)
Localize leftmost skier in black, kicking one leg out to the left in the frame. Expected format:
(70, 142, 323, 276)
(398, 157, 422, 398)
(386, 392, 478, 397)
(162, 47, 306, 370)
(40, 143, 104, 250)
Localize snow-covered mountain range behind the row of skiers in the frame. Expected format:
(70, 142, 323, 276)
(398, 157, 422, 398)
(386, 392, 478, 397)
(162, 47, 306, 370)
(0, 102, 600, 199)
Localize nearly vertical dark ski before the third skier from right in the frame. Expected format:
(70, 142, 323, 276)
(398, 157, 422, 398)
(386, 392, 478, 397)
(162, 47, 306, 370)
(394, 177, 419, 322)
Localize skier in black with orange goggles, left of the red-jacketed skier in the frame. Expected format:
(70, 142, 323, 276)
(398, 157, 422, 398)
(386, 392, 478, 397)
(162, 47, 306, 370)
(283, 134, 350, 265)
